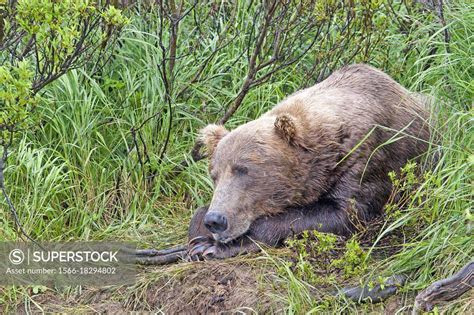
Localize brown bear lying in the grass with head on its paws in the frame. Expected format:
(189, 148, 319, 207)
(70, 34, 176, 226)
(189, 64, 430, 258)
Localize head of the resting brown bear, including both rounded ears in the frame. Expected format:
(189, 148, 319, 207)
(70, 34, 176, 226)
(200, 113, 337, 243)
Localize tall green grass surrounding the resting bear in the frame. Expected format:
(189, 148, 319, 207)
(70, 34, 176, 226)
(0, 1, 474, 313)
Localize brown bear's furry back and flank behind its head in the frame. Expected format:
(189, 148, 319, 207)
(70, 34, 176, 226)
(262, 64, 430, 198)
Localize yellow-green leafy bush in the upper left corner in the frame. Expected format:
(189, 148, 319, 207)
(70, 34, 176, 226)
(0, 0, 129, 150)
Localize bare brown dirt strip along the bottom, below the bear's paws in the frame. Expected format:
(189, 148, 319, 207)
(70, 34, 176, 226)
(10, 257, 283, 314)
